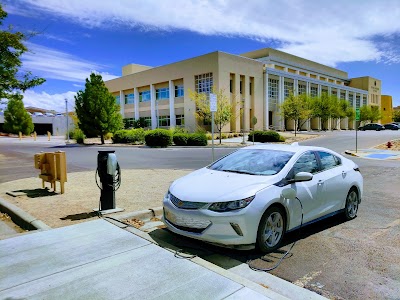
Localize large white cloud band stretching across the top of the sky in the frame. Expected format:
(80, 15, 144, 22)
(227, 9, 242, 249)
(13, 0, 400, 66)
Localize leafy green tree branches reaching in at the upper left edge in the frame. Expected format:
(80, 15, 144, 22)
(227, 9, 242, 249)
(0, 4, 45, 101)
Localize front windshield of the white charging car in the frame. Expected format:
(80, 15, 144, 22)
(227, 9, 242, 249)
(208, 149, 294, 175)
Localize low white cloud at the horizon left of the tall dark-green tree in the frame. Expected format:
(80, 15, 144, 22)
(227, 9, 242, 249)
(23, 90, 76, 112)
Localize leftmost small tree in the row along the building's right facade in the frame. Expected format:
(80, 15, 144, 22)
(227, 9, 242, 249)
(280, 92, 311, 136)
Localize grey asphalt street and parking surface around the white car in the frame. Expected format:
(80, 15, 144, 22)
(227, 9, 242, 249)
(0, 131, 400, 299)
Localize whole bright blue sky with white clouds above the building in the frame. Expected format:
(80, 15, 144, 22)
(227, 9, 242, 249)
(2, 0, 400, 111)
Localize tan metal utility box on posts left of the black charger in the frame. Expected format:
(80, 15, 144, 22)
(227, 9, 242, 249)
(34, 151, 67, 194)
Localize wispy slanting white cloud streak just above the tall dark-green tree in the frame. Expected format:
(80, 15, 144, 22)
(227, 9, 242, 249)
(22, 43, 117, 82)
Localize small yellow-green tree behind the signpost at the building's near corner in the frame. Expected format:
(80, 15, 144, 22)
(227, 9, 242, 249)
(189, 89, 234, 144)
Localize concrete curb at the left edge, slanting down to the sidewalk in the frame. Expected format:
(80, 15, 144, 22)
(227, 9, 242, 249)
(0, 198, 51, 230)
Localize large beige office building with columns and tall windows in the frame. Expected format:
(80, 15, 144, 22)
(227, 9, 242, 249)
(105, 48, 381, 132)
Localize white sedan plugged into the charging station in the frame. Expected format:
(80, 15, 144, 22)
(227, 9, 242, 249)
(163, 143, 363, 252)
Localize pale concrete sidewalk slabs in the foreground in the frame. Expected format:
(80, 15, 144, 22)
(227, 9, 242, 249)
(0, 219, 300, 299)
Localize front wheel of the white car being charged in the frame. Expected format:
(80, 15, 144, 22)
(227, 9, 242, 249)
(257, 206, 286, 252)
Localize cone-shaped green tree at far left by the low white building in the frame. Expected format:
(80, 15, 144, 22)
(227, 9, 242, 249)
(4, 94, 34, 135)
